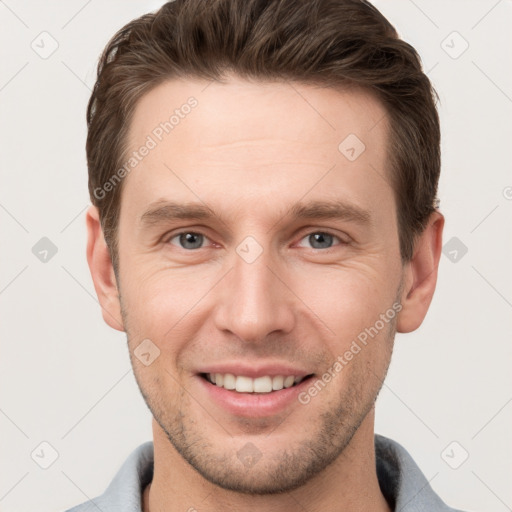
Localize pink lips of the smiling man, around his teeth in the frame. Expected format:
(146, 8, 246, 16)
(196, 368, 314, 418)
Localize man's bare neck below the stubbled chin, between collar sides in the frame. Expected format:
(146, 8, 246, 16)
(142, 409, 391, 512)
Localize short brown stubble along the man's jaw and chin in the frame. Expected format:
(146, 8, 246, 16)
(120, 287, 401, 495)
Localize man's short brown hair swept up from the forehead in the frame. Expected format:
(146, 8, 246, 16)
(86, 0, 441, 269)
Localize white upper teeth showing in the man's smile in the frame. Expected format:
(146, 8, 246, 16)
(206, 373, 304, 393)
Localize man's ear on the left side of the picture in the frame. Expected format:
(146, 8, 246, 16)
(86, 206, 124, 331)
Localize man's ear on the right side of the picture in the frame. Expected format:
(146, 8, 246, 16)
(397, 210, 444, 333)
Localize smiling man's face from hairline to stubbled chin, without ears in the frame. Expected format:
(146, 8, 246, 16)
(118, 77, 403, 493)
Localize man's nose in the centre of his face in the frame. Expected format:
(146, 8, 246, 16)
(214, 243, 296, 343)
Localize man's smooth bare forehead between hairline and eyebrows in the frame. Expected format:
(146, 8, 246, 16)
(122, 76, 392, 218)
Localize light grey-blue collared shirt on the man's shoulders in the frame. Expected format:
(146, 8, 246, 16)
(66, 434, 468, 512)
